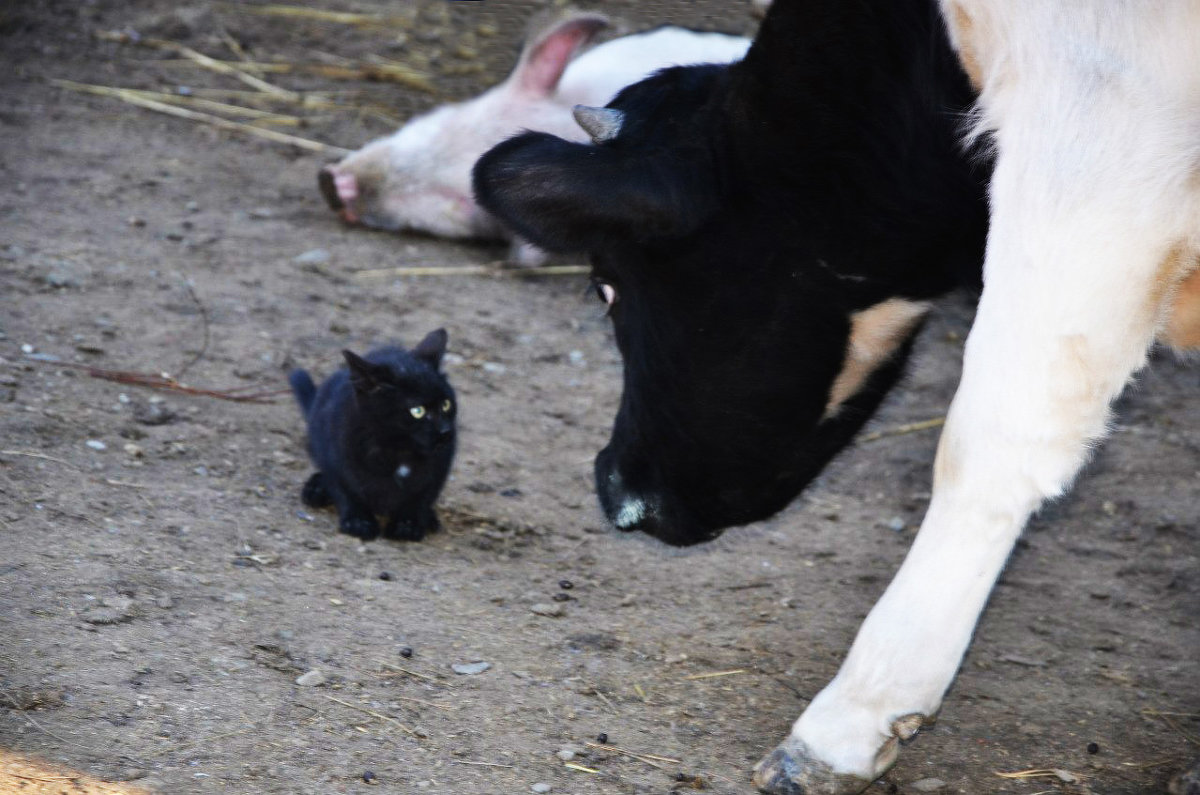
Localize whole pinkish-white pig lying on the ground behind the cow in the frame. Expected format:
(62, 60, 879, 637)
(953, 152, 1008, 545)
(318, 13, 750, 264)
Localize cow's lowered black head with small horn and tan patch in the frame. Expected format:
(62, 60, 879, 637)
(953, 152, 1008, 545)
(475, 4, 984, 545)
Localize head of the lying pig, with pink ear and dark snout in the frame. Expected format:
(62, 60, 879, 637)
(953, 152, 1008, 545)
(318, 13, 608, 238)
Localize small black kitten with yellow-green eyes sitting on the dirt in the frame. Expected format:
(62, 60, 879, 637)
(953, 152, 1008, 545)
(288, 329, 457, 542)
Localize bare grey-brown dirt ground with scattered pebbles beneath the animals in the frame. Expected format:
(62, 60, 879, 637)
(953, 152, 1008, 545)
(0, 0, 1200, 795)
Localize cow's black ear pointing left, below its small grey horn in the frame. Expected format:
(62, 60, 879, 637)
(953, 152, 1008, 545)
(474, 132, 716, 252)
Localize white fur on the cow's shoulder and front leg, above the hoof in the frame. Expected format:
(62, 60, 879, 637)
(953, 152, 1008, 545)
(777, 0, 1200, 779)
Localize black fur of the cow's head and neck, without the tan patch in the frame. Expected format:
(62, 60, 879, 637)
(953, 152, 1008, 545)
(474, 0, 989, 544)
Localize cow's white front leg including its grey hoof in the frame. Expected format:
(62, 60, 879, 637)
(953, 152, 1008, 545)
(755, 90, 1192, 795)
